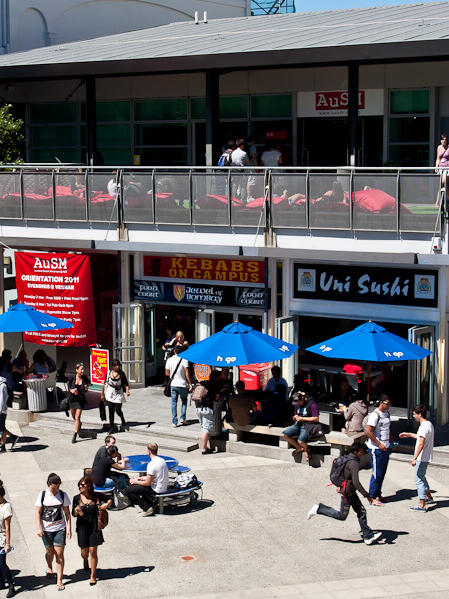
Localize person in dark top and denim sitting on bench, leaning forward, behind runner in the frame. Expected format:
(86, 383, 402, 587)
(282, 391, 323, 461)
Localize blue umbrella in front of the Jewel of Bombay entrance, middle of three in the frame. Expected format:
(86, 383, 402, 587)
(180, 322, 298, 366)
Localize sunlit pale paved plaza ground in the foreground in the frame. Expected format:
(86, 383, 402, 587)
(0, 404, 449, 599)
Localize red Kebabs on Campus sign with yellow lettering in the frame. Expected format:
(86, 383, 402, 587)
(143, 256, 265, 284)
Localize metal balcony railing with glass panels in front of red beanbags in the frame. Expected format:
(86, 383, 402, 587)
(0, 165, 440, 234)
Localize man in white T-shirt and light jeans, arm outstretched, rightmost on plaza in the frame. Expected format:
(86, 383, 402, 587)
(399, 406, 434, 512)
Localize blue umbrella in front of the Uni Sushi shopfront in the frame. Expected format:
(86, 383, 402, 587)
(306, 321, 432, 362)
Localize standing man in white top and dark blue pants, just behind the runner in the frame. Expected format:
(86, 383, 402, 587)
(366, 394, 393, 507)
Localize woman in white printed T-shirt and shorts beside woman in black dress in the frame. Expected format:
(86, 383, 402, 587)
(35, 472, 72, 591)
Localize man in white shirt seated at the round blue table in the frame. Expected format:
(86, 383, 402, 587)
(124, 443, 168, 516)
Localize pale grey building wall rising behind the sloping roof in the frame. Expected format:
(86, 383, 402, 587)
(2, 0, 250, 52)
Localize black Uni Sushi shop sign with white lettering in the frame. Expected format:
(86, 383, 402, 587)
(293, 264, 438, 308)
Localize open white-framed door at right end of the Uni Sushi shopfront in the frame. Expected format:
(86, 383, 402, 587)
(408, 326, 437, 421)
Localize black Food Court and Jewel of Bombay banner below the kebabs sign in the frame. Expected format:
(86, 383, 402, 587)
(134, 280, 269, 310)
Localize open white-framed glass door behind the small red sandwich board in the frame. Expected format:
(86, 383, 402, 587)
(112, 304, 145, 387)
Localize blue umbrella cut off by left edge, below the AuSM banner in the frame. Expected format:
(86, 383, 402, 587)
(0, 304, 73, 333)
